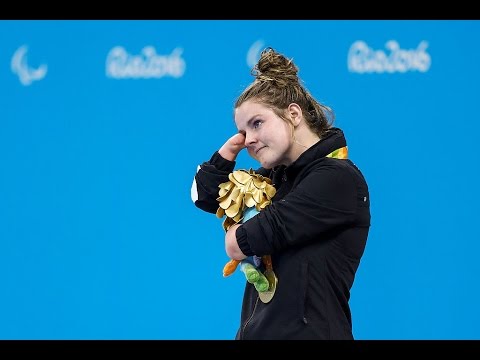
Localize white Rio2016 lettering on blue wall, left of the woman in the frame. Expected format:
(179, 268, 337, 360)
(106, 46, 186, 79)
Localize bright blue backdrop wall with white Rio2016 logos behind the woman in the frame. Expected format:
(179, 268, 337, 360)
(0, 20, 480, 339)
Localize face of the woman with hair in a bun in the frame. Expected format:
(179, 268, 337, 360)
(235, 100, 293, 169)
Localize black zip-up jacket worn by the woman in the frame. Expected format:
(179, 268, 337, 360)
(192, 128, 370, 339)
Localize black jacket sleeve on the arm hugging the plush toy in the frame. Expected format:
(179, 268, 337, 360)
(236, 165, 358, 256)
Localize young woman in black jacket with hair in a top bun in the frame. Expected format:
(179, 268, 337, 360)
(192, 48, 370, 339)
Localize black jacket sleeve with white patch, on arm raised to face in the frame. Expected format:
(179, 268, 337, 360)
(191, 151, 235, 214)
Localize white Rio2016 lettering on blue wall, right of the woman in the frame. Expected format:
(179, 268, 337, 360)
(348, 40, 432, 74)
